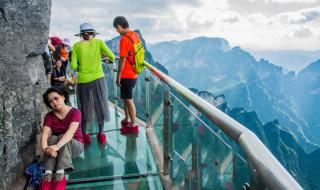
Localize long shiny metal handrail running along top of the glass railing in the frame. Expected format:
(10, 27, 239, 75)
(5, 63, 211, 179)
(145, 61, 303, 190)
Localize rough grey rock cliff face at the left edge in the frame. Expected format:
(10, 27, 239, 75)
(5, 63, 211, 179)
(0, 0, 51, 189)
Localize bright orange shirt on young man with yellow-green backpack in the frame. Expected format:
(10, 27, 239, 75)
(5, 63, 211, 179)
(119, 31, 140, 79)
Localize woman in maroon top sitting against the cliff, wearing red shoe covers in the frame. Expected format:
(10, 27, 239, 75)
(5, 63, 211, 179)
(40, 87, 84, 190)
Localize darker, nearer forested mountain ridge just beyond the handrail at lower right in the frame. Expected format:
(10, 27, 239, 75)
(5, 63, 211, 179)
(192, 89, 320, 190)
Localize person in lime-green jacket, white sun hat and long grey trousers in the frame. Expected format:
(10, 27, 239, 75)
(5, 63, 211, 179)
(71, 23, 115, 144)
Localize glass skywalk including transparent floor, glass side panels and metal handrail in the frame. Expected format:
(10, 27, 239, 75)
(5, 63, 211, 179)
(67, 60, 302, 190)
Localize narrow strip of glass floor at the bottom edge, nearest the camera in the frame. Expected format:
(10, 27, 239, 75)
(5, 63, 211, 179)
(67, 176, 163, 190)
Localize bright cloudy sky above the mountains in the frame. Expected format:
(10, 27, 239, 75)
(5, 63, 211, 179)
(50, 0, 320, 51)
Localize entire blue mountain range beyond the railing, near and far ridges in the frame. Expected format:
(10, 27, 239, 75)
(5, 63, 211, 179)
(106, 32, 320, 190)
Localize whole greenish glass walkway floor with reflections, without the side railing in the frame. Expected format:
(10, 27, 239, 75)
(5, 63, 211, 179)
(67, 101, 163, 190)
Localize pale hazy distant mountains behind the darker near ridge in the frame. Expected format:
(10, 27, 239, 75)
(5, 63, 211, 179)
(149, 37, 320, 152)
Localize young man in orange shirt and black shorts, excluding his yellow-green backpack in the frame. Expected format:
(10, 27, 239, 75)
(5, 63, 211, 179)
(113, 16, 140, 134)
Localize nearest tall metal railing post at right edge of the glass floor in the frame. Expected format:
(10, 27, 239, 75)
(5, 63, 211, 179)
(162, 83, 171, 174)
